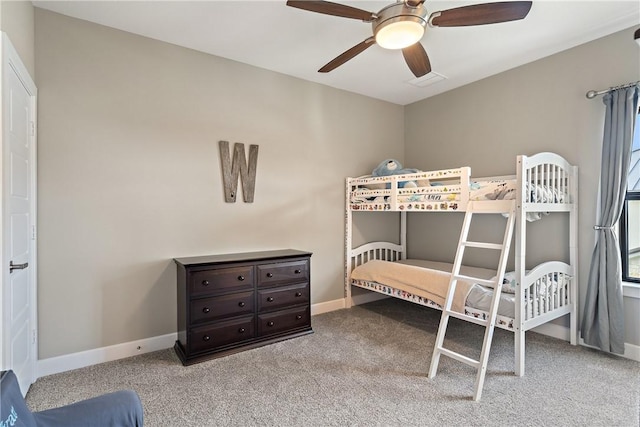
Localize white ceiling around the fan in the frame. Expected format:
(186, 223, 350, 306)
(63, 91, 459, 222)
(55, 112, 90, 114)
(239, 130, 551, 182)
(33, 0, 640, 105)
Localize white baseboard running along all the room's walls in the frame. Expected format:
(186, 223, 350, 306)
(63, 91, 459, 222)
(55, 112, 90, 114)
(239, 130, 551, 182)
(37, 292, 640, 378)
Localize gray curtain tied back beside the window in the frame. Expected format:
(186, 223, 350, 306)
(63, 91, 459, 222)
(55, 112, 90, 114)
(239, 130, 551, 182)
(581, 85, 640, 354)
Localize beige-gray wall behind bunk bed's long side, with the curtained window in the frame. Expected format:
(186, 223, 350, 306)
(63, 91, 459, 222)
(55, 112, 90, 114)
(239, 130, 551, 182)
(405, 28, 640, 345)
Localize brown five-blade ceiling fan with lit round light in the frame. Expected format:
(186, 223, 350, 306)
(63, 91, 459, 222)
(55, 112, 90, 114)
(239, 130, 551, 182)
(287, 0, 533, 77)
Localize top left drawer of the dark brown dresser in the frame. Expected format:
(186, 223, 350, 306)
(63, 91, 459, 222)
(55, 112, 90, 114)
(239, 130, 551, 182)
(190, 265, 253, 295)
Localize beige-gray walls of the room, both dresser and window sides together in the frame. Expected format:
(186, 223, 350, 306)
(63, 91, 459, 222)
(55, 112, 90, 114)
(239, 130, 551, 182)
(32, 7, 640, 358)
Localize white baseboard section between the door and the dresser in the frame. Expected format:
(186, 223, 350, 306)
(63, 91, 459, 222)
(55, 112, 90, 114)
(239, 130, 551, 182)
(37, 333, 178, 378)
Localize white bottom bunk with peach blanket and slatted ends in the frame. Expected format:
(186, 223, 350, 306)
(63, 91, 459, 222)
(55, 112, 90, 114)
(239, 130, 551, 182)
(347, 242, 576, 375)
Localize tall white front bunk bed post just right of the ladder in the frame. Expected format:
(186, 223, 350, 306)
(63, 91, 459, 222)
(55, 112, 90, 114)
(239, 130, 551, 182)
(513, 155, 528, 377)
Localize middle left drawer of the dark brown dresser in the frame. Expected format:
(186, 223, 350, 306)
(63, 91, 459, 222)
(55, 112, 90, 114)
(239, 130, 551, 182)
(189, 291, 254, 324)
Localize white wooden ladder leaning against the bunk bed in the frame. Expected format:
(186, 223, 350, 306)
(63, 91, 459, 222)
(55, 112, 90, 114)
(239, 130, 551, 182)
(429, 201, 516, 400)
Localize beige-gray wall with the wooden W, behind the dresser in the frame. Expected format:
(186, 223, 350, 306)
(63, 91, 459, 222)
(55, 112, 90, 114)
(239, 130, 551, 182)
(35, 9, 404, 358)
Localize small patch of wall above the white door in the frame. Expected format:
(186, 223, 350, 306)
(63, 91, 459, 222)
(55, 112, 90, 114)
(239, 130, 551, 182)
(0, 0, 35, 78)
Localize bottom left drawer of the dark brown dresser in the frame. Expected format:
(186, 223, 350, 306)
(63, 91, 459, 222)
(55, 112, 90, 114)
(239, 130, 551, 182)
(188, 316, 255, 352)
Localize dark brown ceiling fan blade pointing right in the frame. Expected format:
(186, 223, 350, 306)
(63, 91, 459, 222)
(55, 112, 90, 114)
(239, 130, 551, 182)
(429, 1, 533, 27)
